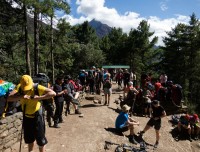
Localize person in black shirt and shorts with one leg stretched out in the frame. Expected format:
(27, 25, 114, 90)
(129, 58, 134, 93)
(140, 100, 166, 148)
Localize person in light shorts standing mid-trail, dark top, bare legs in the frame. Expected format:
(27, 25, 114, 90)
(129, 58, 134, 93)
(103, 74, 112, 106)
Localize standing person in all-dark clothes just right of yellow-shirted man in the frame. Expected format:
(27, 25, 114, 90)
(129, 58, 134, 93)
(53, 77, 67, 128)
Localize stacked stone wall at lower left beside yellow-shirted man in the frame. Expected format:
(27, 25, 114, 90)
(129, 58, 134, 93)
(0, 112, 22, 152)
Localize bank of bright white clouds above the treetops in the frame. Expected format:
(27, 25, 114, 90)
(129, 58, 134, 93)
(58, 0, 189, 45)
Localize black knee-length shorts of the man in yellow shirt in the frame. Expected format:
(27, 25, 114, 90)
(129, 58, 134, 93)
(23, 114, 48, 146)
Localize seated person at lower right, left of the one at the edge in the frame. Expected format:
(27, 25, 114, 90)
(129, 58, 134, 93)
(176, 114, 192, 141)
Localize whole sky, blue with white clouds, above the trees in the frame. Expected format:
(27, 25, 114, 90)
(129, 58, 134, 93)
(57, 0, 200, 45)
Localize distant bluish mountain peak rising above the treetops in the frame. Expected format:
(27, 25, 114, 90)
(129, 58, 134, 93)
(89, 19, 112, 38)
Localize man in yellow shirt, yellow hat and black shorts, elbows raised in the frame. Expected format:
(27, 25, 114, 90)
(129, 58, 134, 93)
(8, 75, 56, 152)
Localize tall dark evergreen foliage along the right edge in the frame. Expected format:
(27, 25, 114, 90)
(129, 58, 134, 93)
(162, 14, 200, 112)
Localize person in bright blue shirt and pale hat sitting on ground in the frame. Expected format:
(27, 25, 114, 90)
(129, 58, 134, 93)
(115, 105, 140, 144)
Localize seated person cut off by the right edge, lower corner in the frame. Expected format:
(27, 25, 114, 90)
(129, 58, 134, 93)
(189, 114, 200, 140)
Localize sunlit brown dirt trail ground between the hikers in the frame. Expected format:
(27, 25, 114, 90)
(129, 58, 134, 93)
(12, 85, 200, 152)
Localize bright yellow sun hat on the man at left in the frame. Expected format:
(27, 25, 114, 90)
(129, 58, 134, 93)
(20, 75, 33, 91)
